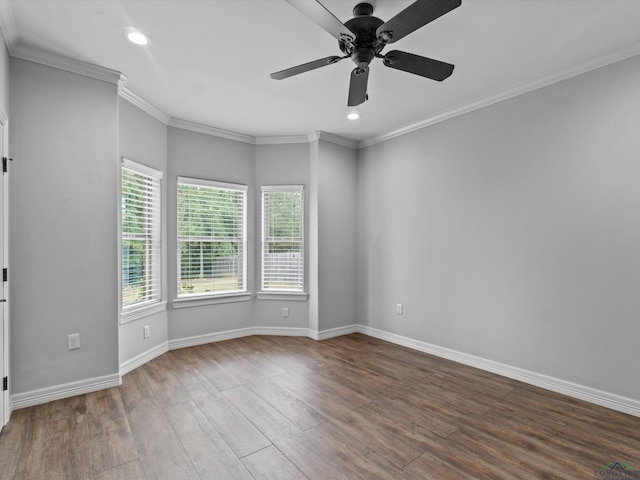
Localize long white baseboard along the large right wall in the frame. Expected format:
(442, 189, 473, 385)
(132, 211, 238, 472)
(358, 325, 640, 417)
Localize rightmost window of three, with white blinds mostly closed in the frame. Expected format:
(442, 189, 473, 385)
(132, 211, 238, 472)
(262, 185, 304, 292)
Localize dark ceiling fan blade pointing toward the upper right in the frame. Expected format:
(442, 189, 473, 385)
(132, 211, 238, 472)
(376, 0, 462, 43)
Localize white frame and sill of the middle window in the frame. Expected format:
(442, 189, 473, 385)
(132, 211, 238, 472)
(173, 176, 251, 302)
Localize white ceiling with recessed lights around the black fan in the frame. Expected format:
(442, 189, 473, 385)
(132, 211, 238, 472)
(0, 0, 640, 145)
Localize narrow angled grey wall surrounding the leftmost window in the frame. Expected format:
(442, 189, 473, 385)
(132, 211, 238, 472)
(118, 99, 170, 365)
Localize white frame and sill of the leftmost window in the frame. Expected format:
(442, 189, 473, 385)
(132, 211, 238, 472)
(118, 157, 166, 323)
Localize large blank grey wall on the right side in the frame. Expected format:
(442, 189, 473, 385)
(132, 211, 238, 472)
(358, 53, 640, 400)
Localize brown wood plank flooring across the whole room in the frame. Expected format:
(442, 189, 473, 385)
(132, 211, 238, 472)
(0, 334, 640, 480)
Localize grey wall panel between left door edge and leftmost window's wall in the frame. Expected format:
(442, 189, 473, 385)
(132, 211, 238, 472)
(9, 58, 119, 395)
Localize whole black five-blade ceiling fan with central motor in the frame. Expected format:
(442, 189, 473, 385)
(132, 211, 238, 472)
(271, 0, 462, 107)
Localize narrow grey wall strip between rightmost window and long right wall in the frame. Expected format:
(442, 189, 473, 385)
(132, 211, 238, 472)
(310, 138, 357, 333)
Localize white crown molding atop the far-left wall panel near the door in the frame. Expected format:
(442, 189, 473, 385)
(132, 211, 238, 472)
(9, 43, 127, 88)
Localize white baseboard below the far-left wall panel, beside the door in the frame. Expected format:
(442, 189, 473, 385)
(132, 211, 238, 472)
(11, 373, 122, 411)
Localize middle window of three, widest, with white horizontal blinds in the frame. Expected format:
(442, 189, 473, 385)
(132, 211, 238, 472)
(178, 177, 247, 297)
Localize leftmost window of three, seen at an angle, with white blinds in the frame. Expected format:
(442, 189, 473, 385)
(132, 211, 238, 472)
(121, 158, 162, 313)
